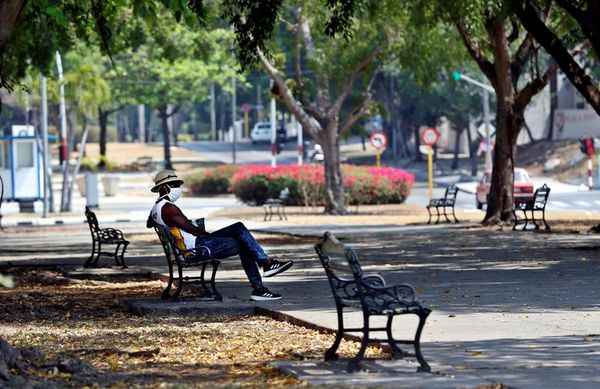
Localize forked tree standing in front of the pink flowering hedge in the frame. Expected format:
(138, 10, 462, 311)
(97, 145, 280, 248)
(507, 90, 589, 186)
(255, 1, 401, 214)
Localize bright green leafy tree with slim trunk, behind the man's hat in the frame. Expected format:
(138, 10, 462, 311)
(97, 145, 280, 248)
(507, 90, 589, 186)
(115, 18, 244, 168)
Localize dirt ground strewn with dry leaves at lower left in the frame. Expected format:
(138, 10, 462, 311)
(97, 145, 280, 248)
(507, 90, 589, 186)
(0, 269, 383, 388)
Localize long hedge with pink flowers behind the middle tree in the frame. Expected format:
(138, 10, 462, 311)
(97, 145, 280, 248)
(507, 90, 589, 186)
(192, 165, 415, 205)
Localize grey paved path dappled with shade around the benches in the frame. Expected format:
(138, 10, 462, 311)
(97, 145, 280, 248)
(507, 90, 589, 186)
(0, 219, 600, 388)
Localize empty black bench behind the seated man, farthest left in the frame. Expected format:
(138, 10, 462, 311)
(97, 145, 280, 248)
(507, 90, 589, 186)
(83, 206, 129, 268)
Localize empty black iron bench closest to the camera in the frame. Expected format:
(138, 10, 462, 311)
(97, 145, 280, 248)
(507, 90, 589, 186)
(315, 232, 431, 372)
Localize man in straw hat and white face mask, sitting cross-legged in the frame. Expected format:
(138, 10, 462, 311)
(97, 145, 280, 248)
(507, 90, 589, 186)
(147, 170, 293, 301)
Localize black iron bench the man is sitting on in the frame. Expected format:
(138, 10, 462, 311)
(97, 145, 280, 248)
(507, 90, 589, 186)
(154, 221, 223, 301)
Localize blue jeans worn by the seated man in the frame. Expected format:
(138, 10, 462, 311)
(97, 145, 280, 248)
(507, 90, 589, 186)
(196, 222, 269, 288)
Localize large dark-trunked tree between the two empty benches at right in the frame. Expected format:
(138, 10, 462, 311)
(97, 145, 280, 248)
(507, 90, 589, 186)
(414, 0, 558, 224)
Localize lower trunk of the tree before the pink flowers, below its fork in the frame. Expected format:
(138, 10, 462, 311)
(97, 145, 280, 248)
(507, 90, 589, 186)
(321, 120, 347, 215)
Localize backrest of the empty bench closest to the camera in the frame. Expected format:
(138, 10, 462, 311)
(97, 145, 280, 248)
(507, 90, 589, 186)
(315, 232, 362, 303)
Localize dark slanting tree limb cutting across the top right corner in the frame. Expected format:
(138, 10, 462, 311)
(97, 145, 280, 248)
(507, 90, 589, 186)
(511, 0, 600, 115)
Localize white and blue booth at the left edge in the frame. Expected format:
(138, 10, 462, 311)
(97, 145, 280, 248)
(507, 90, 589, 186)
(0, 126, 44, 212)
